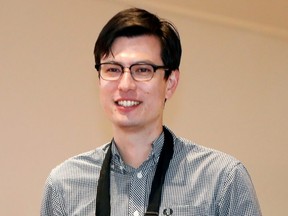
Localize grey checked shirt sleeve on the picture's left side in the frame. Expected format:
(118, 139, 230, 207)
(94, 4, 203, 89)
(40, 174, 66, 216)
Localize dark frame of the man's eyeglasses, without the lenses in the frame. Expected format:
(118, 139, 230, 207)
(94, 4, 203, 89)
(95, 62, 169, 82)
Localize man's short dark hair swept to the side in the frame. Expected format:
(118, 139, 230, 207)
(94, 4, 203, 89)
(94, 8, 182, 78)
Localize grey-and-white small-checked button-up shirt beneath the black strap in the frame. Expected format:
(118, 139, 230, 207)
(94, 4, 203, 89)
(41, 127, 261, 216)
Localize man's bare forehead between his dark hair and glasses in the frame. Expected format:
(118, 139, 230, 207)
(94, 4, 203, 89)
(103, 35, 162, 63)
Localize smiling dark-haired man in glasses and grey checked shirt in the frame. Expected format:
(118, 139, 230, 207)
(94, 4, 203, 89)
(41, 8, 261, 216)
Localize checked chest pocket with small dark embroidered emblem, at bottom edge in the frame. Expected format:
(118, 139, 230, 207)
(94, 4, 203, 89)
(160, 205, 208, 216)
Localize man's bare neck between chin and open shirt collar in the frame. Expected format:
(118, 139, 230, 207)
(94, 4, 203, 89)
(114, 125, 163, 168)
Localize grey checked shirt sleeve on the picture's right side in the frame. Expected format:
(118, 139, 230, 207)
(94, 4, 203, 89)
(218, 163, 262, 216)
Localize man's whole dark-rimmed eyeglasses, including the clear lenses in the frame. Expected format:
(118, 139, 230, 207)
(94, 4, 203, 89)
(95, 62, 168, 81)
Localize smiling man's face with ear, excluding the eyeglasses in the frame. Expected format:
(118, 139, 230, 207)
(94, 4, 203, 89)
(99, 35, 178, 130)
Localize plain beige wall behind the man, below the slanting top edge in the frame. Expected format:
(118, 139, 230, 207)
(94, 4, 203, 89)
(0, 0, 288, 216)
